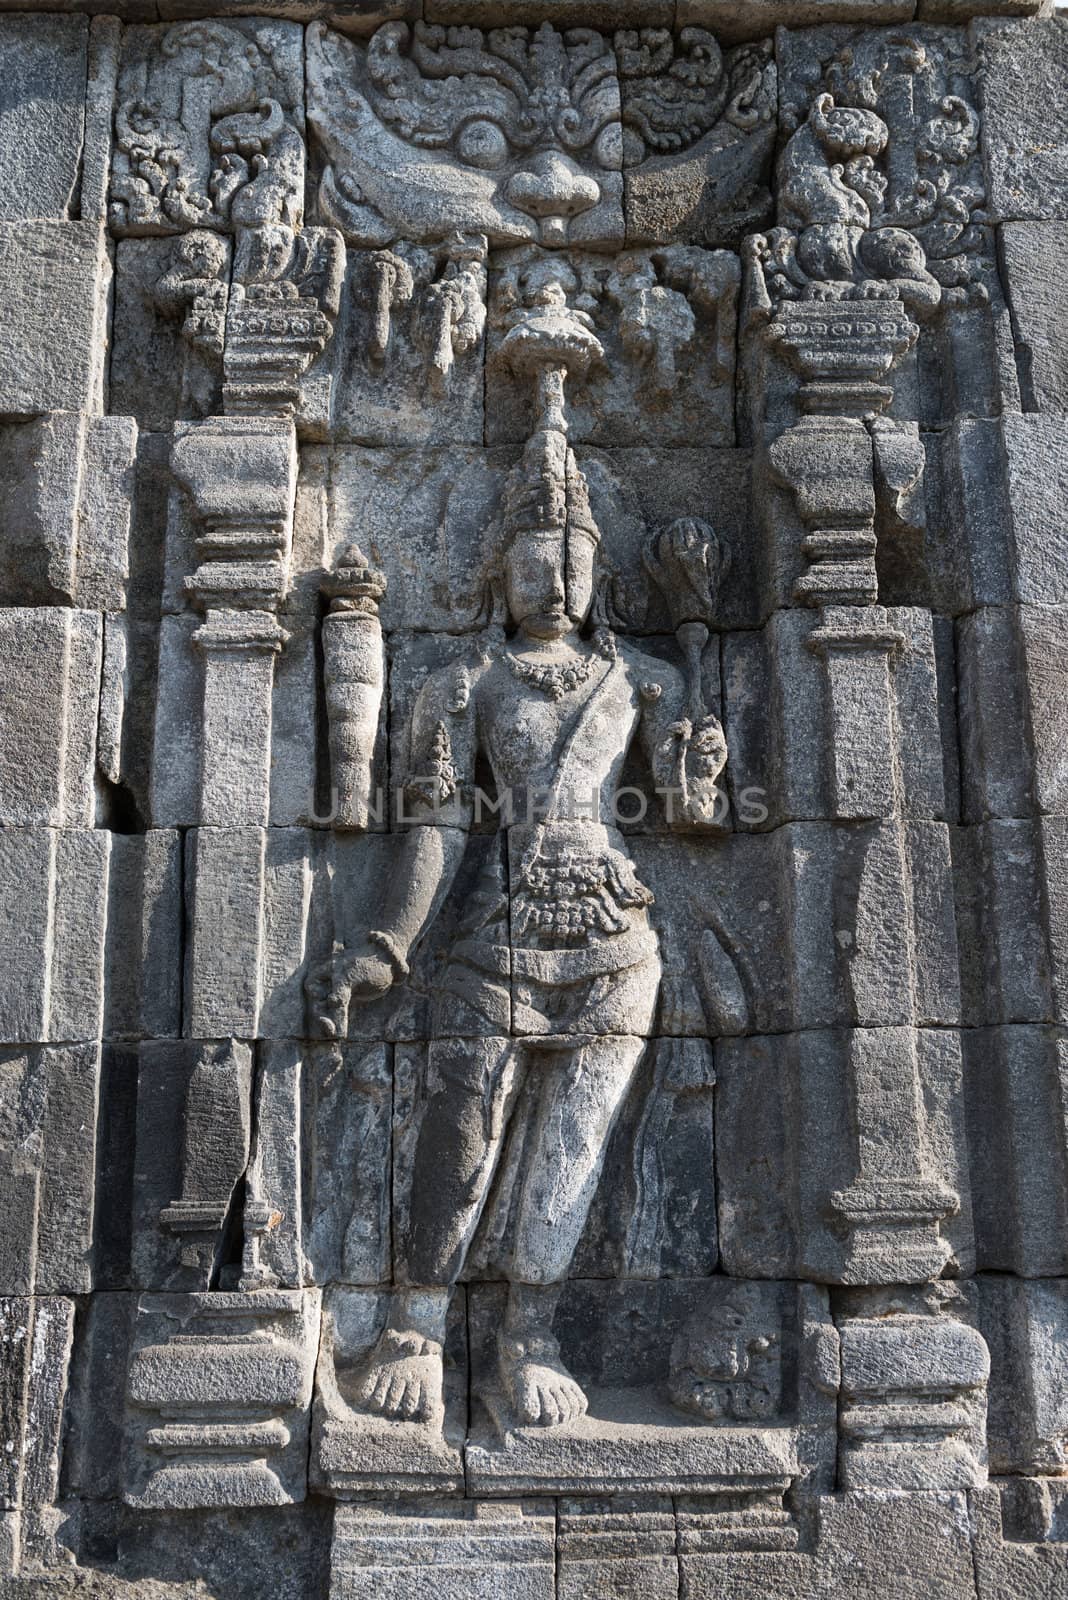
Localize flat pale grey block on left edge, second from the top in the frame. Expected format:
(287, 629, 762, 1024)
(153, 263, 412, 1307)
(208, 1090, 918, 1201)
(0, 219, 110, 416)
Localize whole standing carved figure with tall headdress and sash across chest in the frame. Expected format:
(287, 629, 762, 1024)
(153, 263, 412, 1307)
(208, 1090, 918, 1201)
(309, 427, 726, 1427)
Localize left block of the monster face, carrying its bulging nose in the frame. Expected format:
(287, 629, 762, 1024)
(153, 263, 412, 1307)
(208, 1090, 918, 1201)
(309, 22, 624, 246)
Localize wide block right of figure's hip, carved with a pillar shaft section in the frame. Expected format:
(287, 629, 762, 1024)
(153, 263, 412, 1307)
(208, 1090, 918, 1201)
(633, 822, 959, 1035)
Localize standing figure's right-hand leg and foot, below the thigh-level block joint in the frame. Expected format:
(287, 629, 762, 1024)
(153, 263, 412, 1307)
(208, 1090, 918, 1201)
(497, 1035, 646, 1427)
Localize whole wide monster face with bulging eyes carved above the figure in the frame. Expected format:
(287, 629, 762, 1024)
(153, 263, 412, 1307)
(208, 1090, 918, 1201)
(309, 22, 775, 250)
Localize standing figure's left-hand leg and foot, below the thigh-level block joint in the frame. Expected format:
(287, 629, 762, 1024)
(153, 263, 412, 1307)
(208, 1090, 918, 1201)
(358, 1038, 516, 1422)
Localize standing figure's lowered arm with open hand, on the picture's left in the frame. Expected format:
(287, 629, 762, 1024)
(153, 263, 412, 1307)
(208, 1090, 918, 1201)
(305, 669, 475, 1038)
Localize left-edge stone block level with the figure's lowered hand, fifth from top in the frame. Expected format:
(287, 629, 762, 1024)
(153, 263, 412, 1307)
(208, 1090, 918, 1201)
(0, 827, 110, 1043)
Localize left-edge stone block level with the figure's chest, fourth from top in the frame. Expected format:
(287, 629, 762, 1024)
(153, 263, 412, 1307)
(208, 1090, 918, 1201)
(0, 606, 102, 827)
